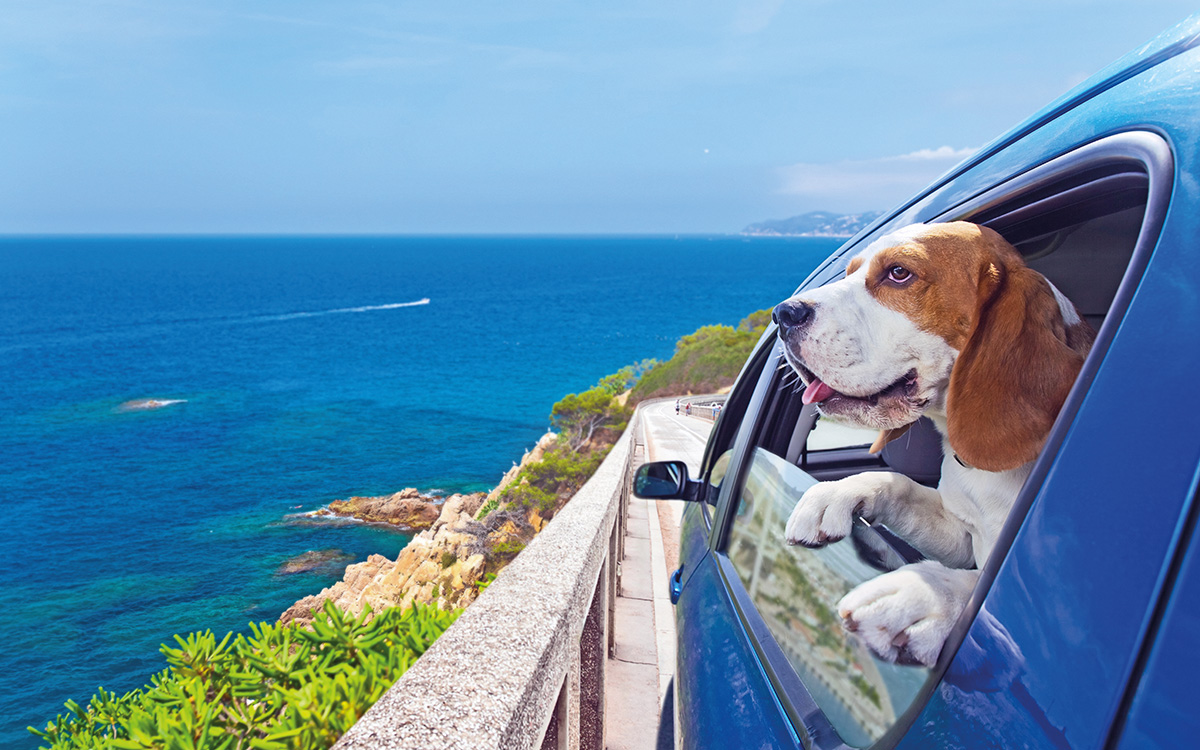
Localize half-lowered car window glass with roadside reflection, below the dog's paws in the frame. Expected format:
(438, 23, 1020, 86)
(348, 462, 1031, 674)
(728, 448, 929, 748)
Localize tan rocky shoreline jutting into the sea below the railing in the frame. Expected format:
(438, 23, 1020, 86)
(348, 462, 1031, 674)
(280, 433, 557, 624)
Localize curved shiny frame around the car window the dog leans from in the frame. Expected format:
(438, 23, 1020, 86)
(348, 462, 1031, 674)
(706, 128, 1175, 750)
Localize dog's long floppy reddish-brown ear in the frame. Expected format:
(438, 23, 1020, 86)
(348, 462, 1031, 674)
(946, 233, 1084, 472)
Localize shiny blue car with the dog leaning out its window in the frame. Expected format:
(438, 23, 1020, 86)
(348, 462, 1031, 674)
(642, 17, 1200, 749)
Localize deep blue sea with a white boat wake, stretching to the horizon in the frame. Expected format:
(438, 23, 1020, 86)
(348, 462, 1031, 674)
(0, 235, 840, 748)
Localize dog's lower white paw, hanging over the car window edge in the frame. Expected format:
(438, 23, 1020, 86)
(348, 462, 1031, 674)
(838, 560, 979, 667)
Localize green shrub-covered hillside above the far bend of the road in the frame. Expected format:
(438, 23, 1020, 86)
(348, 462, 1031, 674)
(630, 310, 770, 403)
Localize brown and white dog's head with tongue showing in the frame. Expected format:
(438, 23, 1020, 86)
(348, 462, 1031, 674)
(774, 222, 1094, 472)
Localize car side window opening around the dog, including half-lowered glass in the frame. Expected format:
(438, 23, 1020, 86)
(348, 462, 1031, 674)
(722, 141, 1150, 748)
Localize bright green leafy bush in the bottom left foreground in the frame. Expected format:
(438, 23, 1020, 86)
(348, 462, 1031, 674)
(30, 602, 460, 750)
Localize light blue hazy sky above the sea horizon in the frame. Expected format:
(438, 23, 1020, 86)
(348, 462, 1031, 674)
(0, 0, 1195, 233)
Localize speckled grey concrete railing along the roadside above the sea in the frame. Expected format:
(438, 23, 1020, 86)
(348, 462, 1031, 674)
(335, 415, 643, 750)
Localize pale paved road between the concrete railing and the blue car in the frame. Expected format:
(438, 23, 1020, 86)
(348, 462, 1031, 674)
(605, 400, 713, 750)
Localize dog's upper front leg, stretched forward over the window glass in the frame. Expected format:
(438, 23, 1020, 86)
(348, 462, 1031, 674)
(784, 472, 974, 568)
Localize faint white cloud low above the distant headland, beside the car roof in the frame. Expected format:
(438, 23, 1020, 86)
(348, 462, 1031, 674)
(779, 145, 976, 209)
